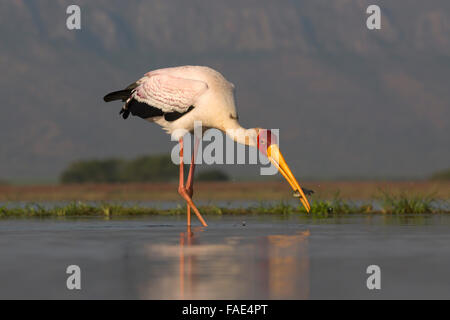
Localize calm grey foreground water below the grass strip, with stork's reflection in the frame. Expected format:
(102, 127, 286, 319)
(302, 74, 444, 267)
(0, 215, 450, 299)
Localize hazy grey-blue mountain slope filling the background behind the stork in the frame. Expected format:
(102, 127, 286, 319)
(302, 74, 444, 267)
(0, 0, 450, 179)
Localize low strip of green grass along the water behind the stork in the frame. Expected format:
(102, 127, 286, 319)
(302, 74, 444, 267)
(0, 192, 450, 218)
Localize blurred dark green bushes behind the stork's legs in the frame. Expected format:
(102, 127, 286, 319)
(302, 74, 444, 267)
(60, 155, 229, 183)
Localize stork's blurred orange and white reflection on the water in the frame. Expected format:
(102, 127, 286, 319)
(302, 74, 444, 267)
(179, 227, 310, 299)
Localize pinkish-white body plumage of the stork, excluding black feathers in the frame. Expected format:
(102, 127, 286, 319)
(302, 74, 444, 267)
(118, 66, 242, 138)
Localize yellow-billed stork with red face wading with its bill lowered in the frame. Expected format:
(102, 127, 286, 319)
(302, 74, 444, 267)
(103, 66, 310, 226)
